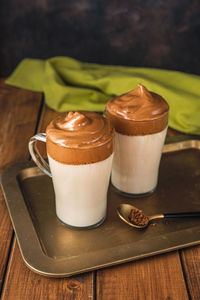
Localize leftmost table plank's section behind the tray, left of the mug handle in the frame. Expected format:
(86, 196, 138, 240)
(0, 80, 42, 172)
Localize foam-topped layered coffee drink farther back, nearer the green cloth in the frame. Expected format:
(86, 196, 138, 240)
(106, 85, 169, 196)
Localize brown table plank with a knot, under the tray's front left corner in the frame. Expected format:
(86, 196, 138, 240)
(2, 106, 94, 300)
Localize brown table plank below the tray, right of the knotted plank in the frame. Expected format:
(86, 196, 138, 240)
(97, 252, 188, 300)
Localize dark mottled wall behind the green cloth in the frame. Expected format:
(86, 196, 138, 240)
(0, 0, 200, 76)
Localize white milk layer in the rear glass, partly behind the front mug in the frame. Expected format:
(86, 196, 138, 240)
(111, 128, 167, 194)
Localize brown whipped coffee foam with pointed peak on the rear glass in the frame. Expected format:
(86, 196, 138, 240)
(107, 84, 169, 135)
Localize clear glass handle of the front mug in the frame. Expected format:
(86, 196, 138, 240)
(28, 133, 52, 177)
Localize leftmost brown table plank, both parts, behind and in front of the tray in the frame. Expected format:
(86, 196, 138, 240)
(0, 80, 41, 290)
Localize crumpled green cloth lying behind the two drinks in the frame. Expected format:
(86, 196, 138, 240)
(6, 57, 200, 134)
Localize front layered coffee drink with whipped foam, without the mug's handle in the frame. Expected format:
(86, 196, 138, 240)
(46, 112, 114, 228)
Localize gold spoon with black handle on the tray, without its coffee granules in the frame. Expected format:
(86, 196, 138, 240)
(117, 204, 200, 229)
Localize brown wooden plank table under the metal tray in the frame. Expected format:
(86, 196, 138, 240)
(0, 80, 200, 300)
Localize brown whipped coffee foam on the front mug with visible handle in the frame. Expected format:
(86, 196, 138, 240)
(46, 112, 114, 165)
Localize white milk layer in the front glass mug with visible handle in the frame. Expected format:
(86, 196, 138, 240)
(48, 154, 113, 227)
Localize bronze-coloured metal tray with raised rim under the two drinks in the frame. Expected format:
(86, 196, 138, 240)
(1, 140, 200, 277)
